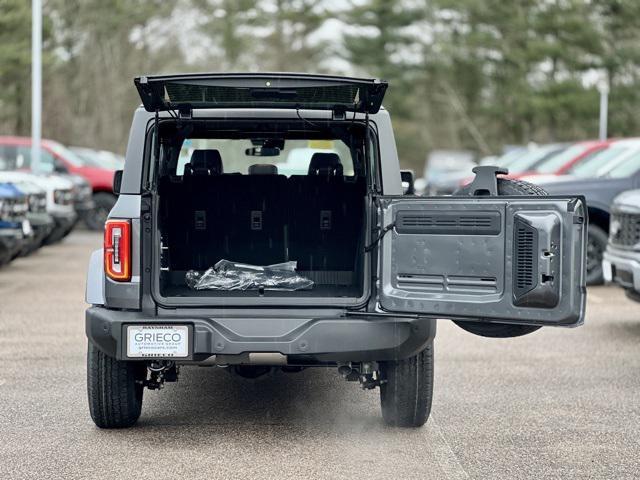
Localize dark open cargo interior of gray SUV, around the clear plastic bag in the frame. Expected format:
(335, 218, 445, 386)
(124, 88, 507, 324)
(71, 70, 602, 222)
(152, 118, 367, 299)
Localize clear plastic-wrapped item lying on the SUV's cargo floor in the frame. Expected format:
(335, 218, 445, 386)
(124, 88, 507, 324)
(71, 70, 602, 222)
(185, 260, 313, 292)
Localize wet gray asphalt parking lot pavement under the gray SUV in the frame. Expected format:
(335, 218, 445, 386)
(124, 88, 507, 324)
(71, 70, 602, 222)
(0, 232, 640, 479)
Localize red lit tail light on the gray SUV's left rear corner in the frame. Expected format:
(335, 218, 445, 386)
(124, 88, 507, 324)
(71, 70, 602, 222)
(104, 220, 131, 282)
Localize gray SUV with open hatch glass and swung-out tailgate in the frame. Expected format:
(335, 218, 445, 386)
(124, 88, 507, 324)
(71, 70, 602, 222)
(86, 74, 587, 428)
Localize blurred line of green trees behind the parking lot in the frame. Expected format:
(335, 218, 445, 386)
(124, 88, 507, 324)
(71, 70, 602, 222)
(0, 0, 640, 171)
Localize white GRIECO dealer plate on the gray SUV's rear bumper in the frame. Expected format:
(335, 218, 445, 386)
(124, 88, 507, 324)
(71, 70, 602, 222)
(127, 325, 189, 358)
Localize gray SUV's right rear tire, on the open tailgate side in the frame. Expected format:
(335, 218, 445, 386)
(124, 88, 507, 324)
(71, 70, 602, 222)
(380, 342, 433, 427)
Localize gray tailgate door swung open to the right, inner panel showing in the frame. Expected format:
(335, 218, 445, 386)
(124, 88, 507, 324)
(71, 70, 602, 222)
(378, 196, 587, 326)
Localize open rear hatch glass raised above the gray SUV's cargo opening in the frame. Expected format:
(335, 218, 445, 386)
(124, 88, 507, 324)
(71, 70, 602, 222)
(134, 73, 387, 113)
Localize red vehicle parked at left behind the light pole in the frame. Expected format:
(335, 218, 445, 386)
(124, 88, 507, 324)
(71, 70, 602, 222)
(0, 137, 116, 230)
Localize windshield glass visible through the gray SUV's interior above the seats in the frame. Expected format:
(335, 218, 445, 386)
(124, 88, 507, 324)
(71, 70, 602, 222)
(175, 138, 354, 176)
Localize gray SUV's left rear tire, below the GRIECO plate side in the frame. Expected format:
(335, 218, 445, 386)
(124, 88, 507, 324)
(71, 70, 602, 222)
(87, 342, 147, 428)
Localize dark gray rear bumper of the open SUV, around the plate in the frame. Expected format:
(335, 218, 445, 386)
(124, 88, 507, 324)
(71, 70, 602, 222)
(86, 307, 436, 363)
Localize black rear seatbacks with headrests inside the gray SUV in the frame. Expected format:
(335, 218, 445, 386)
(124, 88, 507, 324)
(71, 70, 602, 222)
(160, 150, 364, 271)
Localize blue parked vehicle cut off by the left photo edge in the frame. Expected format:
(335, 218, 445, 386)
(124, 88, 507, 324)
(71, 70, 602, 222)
(0, 183, 31, 266)
